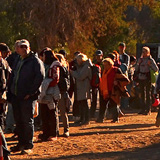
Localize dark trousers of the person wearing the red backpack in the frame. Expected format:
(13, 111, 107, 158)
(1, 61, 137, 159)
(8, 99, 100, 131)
(90, 87, 98, 118)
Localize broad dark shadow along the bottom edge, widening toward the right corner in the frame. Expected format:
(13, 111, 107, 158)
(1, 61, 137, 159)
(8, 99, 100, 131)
(13, 142, 160, 160)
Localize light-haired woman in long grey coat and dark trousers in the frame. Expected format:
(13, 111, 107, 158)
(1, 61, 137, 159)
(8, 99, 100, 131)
(71, 53, 92, 125)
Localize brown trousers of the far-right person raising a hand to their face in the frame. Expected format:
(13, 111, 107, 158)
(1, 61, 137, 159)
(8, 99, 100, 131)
(139, 80, 151, 112)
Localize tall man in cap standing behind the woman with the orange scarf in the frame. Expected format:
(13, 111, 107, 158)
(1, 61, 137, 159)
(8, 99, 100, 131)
(118, 42, 130, 109)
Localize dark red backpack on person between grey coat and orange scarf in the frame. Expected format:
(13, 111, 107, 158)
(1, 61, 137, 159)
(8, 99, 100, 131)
(91, 64, 101, 88)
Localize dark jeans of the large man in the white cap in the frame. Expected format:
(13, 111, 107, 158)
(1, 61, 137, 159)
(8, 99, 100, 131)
(12, 96, 36, 149)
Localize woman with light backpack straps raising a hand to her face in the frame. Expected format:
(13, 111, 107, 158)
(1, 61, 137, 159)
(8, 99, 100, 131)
(136, 47, 158, 115)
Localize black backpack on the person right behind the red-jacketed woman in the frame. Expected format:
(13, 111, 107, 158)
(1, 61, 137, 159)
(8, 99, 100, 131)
(58, 66, 70, 92)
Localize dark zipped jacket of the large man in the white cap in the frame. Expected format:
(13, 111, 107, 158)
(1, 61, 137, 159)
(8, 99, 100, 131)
(9, 52, 45, 100)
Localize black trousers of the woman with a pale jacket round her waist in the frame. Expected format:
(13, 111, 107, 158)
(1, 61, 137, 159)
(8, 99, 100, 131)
(41, 104, 59, 139)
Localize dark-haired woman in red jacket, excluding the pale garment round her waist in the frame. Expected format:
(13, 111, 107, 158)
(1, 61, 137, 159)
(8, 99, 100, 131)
(38, 50, 61, 141)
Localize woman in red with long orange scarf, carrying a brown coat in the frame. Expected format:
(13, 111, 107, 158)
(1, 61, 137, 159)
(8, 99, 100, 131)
(99, 58, 129, 123)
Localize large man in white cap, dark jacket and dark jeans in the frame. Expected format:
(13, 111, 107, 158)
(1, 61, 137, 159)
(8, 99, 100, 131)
(9, 39, 45, 153)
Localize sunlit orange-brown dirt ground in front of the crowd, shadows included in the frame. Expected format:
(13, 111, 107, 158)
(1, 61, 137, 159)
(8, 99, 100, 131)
(5, 112, 160, 160)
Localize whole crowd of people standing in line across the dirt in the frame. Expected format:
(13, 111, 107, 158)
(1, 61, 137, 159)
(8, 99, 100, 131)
(0, 39, 160, 160)
